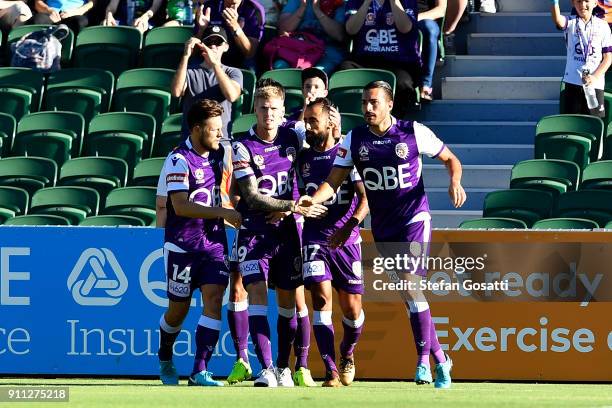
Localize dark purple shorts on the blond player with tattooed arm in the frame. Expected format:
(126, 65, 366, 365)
(238, 222, 303, 290)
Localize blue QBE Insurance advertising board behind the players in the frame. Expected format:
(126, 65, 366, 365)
(0, 227, 276, 375)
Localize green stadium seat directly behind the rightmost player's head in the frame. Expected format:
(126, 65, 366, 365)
(328, 68, 397, 115)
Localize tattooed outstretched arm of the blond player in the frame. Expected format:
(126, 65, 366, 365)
(237, 177, 327, 216)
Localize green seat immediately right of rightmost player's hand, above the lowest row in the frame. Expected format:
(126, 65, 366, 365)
(483, 189, 554, 227)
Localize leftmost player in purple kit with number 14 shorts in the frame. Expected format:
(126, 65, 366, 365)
(158, 99, 242, 386)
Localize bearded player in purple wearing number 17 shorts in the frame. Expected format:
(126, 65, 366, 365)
(297, 98, 368, 387)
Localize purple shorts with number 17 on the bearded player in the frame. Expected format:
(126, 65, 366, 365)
(302, 244, 363, 295)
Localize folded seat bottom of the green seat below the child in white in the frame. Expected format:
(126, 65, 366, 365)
(534, 133, 594, 169)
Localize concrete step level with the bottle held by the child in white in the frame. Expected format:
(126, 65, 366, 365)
(442, 77, 561, 100)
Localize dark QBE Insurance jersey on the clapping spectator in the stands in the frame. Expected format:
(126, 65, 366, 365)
(346, 0, 421, 64)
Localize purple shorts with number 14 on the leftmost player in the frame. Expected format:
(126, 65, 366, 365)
(164, 249, 229, 302)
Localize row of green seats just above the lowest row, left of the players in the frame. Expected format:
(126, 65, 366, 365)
(0, 186, 156, 225)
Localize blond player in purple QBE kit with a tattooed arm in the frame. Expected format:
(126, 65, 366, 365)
(232, 80, 326, 387)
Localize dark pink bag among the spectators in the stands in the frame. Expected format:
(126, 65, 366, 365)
(263, 32, 325, 69)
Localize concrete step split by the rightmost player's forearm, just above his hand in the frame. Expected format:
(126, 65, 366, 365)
(423, 164, 512, 190)
